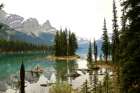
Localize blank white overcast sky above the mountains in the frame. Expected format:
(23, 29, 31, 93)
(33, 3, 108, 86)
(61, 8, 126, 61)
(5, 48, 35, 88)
(0, 0, 121, 39)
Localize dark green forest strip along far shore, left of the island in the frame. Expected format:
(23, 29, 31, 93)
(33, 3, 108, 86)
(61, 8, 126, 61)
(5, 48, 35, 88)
(0, 40, 48, 52)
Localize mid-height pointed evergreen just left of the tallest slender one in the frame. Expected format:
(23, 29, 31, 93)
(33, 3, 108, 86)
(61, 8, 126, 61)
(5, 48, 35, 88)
(102, 19, 110, 63)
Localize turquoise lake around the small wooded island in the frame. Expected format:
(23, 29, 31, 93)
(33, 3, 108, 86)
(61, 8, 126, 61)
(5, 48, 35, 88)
(0, 49, 107, 91)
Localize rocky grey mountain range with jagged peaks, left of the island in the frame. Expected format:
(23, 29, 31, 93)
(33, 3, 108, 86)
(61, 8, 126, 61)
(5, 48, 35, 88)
(0, 10, 56, 45)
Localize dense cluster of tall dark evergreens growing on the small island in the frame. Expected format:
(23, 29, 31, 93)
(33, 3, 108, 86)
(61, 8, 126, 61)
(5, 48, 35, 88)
(54, 29, 78, 56)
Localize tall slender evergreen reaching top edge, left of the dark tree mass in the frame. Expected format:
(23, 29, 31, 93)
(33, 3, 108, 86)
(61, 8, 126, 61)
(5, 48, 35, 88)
(112, 0, 119, 63)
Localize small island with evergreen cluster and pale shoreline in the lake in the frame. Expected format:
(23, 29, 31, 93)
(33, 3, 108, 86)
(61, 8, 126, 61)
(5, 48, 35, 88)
(47, 29, 80, 60)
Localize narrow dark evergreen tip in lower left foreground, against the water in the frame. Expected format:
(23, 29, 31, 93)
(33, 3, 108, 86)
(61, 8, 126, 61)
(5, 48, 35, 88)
(20, 62, 25, 93)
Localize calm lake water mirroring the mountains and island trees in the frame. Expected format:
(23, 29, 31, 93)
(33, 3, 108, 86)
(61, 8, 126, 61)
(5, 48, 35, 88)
(0, 53, 112, 91)
